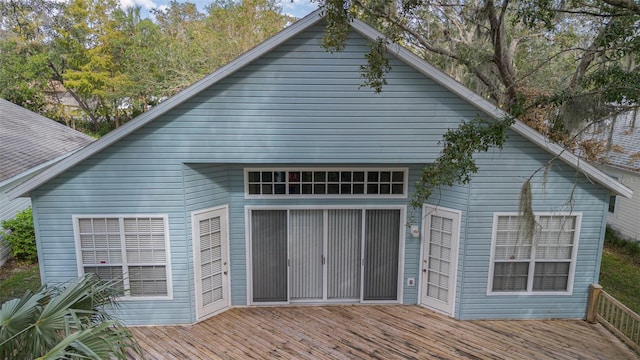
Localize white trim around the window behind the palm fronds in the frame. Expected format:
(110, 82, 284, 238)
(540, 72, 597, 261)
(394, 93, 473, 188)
(72, 214, 173, 301)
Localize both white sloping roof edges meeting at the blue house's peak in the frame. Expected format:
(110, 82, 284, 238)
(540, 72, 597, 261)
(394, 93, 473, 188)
(8, 9, 633, 197)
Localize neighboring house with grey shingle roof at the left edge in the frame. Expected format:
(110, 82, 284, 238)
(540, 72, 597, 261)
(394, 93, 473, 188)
(0, 99, 93, 265)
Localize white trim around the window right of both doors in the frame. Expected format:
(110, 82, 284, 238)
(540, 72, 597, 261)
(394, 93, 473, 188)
(487, 212, 582, 296)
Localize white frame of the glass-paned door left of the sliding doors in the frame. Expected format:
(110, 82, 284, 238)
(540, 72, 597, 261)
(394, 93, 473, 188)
(191, 205, 231, 321)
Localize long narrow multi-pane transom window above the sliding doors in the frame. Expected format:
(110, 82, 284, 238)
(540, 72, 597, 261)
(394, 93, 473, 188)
(245, 168, 407, 197)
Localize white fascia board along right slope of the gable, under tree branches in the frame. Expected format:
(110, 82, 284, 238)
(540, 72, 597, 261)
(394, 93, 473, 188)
(352, 20, 633, 198)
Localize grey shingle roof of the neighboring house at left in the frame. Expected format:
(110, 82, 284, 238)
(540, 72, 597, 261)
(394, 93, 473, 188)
(0, 99, 93, 184)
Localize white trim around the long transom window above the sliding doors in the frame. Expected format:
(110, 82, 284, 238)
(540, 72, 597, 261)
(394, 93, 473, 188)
(244, 166, 409, 199)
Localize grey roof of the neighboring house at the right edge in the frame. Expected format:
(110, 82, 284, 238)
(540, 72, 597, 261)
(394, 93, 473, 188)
(583, 110, 640, 172)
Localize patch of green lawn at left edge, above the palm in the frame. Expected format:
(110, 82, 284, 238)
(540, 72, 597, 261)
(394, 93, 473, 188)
(0, 260, 40, 304)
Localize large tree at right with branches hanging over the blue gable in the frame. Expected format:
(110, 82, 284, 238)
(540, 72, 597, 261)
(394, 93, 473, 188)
(321, 0, 640, 204)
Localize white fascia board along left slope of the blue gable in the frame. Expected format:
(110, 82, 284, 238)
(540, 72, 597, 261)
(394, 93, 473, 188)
(7, 10, 322, 200)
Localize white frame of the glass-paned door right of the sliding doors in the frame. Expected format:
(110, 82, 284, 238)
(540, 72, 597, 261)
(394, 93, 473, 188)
(418, 204, 462, 317)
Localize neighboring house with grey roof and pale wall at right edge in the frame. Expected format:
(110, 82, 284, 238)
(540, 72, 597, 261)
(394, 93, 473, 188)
(585, 110, 640, 241)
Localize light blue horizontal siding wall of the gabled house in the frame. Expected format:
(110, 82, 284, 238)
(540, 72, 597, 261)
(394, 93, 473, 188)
(32, 26, 607, 324)
